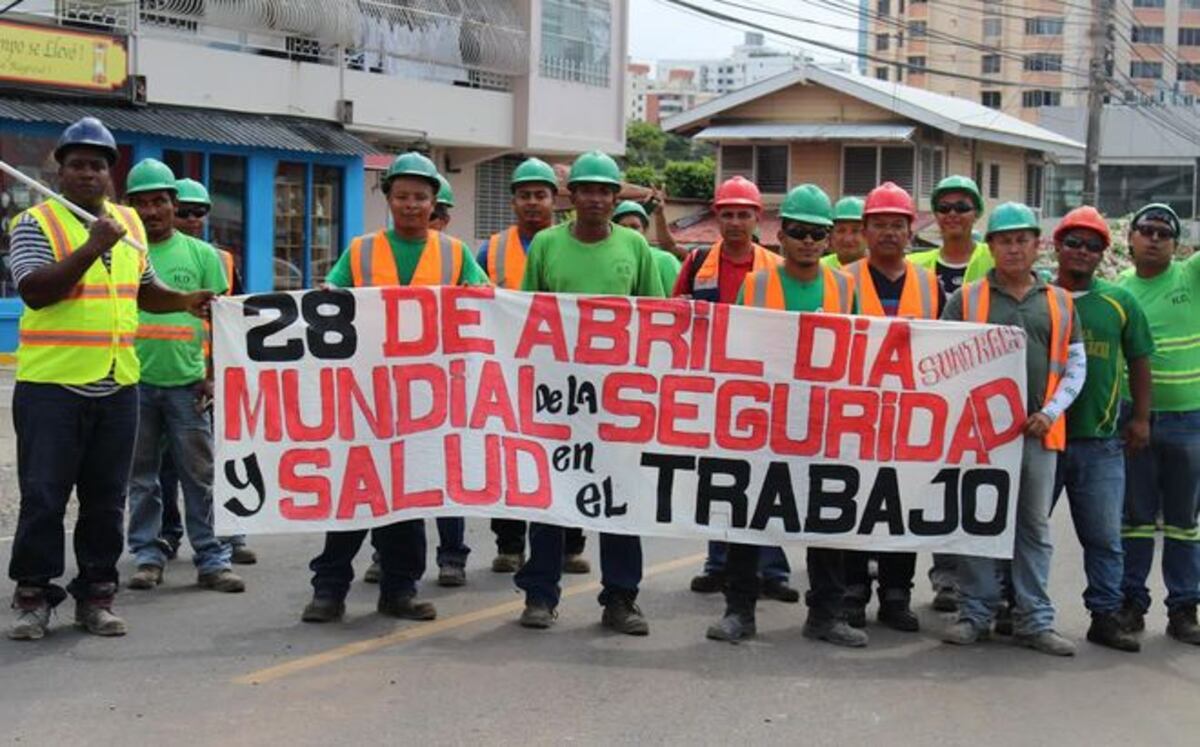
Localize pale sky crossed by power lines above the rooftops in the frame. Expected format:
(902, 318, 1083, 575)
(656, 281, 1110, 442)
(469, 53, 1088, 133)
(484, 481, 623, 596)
(629, 0, 858, 61)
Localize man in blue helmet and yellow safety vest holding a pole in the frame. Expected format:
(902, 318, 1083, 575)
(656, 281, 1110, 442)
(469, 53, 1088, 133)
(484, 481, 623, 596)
(8, 116, 212, 640)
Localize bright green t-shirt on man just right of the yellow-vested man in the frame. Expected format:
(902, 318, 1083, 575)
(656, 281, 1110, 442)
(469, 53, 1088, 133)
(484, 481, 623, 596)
(136, 231, 229, 387)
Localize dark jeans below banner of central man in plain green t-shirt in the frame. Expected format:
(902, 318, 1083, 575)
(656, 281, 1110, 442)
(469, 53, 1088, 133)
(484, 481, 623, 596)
(514, 522, 642, 606)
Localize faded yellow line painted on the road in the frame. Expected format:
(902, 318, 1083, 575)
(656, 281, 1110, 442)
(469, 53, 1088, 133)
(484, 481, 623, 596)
(233, 552, 704, 685)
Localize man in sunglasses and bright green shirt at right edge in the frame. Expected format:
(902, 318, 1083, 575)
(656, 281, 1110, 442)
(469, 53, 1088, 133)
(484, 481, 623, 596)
(1117, 203, 1200, 645)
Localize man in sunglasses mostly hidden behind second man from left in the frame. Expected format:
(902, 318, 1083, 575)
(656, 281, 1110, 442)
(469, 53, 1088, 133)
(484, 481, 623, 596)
(158, 179, 258, 566)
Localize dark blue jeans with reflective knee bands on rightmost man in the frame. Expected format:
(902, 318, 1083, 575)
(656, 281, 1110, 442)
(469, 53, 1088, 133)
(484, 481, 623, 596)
(1121, 411, 1200, 611)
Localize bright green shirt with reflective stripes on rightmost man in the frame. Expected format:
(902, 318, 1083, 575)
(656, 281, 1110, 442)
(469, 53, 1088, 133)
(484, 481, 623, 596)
(1117, 252, 1200, 412)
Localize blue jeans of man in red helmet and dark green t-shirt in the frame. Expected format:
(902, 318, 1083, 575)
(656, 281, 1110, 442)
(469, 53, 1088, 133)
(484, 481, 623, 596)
(1054, 438, 1124, 615)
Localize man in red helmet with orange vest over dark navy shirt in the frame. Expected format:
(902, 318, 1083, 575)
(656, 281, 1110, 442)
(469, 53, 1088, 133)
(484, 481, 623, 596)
(846, 181, 946, 632)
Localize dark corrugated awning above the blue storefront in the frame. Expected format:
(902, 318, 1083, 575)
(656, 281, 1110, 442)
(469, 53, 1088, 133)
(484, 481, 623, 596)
(0, 98, 376, 156)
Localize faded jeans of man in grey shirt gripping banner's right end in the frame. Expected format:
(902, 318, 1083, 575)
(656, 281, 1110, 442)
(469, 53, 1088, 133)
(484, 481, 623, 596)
(958, 438, 1057, 635)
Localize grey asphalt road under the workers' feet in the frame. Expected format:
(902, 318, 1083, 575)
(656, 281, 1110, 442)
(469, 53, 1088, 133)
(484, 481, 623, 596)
(0, 507, 1200, 746)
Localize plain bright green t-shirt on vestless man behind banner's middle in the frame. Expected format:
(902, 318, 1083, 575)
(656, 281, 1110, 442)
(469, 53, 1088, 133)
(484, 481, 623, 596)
(521, 222, 666, 298)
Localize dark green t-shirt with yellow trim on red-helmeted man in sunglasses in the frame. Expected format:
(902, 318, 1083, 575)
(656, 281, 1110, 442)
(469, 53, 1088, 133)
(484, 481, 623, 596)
(1067, 280, 1154, 438)
